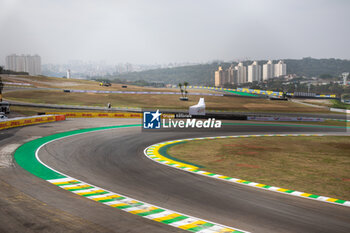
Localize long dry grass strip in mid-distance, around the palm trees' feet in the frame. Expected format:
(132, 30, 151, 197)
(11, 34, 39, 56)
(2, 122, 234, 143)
(4, 90, 327, 112)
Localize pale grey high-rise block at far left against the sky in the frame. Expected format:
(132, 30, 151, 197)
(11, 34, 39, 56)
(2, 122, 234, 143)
(6, 54, 41, 75)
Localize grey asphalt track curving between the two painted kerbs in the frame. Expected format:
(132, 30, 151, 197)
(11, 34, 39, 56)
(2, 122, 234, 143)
(18, 124, 350, 232)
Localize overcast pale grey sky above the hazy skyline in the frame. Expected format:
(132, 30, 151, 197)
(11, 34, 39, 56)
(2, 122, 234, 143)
(0, 0, 350, 64)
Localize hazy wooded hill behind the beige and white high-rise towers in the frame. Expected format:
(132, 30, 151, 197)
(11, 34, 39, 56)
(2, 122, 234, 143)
(109, 58, 350, 86)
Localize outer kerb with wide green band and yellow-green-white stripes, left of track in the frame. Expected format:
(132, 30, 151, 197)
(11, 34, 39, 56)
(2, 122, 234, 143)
(14, 125, 246, 233)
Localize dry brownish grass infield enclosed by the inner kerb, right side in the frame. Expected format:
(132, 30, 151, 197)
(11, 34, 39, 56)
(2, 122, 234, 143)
(167, 136, 350, 200)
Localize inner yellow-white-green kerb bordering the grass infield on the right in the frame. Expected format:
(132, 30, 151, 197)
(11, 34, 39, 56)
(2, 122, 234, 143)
(144, 134, 350, 207)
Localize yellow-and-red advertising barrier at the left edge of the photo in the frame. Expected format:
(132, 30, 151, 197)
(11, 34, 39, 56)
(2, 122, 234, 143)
(0, 114, 66, 130)
